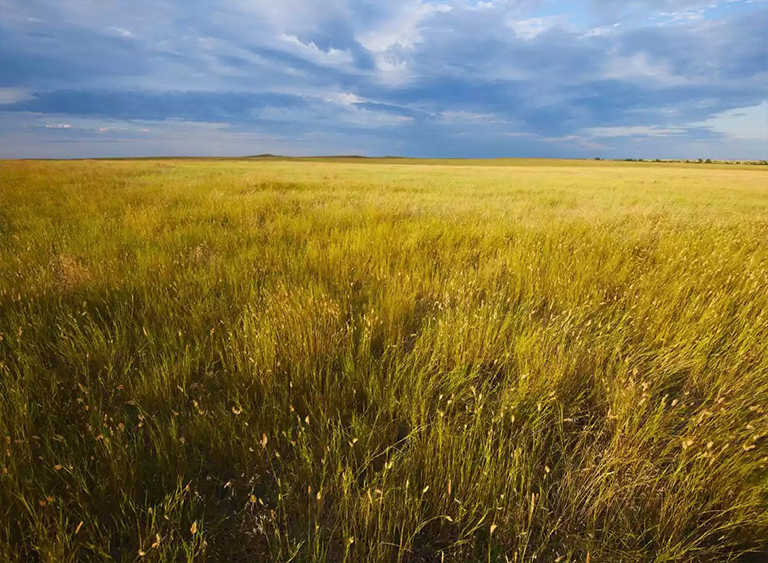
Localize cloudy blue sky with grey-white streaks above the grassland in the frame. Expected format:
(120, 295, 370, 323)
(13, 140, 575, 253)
(0, 0, 768, 159)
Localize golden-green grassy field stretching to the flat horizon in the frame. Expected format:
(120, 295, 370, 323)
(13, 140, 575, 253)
(0, 159, 768, 563)
